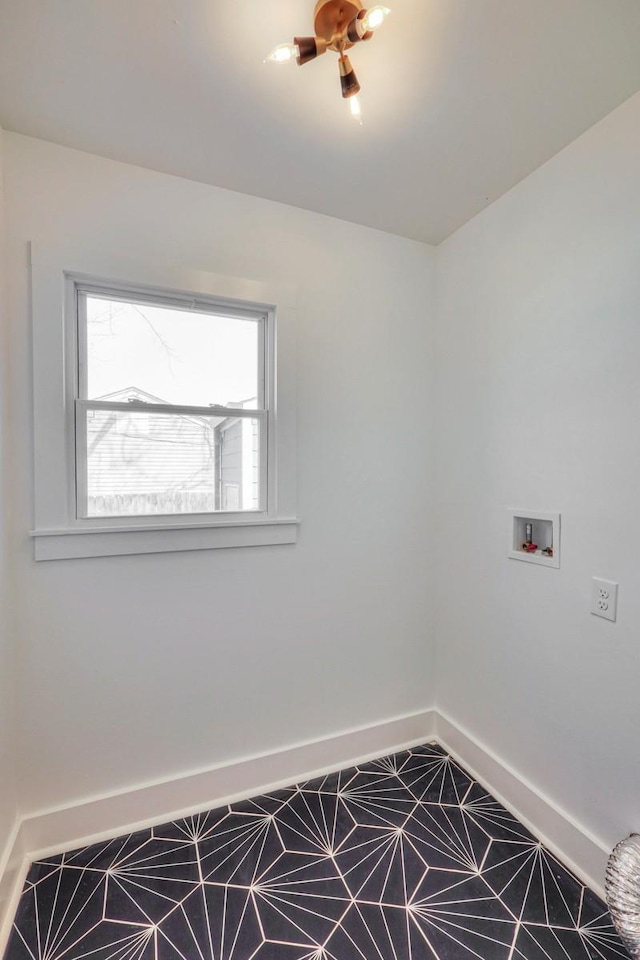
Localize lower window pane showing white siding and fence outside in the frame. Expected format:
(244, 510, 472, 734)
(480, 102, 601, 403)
(86, 410, 260, 517)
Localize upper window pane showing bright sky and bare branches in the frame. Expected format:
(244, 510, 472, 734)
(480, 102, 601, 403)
(85, 294, 262, 407)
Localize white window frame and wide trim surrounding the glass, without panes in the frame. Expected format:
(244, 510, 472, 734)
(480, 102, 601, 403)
(30, 245, 298, 560)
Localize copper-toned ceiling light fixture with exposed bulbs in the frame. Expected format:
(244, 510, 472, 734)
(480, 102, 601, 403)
(267, 0, 389, 123)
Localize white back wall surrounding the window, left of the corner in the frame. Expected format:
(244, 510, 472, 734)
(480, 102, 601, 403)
(6, 134, 433, 813)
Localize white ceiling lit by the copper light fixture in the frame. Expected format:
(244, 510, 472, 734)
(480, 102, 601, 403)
(0, 0, 640, 243)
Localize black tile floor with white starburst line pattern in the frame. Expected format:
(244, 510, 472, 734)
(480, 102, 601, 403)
(6, 744, 628, 960)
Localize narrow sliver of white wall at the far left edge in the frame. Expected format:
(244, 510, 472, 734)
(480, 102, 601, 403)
(0, 129, 17, 915)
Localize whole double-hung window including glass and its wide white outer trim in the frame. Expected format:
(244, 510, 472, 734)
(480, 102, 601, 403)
(32, 248, 297, 559)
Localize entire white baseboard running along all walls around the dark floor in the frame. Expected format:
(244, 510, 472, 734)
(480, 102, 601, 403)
(0, 710, 608, 957)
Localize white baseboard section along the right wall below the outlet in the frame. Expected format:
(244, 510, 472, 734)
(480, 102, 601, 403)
(434, 710, 610, 900)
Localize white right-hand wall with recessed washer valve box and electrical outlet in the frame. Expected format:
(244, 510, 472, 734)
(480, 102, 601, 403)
(435, 94, 640, 847)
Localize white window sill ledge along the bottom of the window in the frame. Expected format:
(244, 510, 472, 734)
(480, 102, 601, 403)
(30, 519, 299, 560)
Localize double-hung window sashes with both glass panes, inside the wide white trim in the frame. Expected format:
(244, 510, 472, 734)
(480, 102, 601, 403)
(75, 284, 271, 518)
